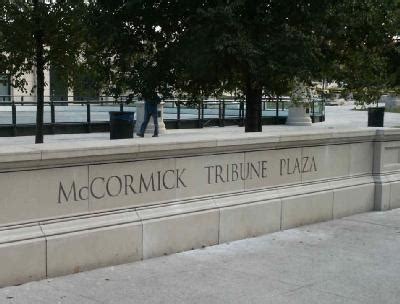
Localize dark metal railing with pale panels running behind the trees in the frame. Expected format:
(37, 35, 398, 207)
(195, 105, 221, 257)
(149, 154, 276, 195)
(0, 95, 325, 136)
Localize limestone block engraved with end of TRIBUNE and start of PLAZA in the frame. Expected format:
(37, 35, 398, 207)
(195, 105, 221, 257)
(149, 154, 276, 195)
(245, 148, 309, 189)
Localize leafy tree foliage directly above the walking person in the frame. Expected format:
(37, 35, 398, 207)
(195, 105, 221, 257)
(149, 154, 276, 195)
(83, 0, 179, 97)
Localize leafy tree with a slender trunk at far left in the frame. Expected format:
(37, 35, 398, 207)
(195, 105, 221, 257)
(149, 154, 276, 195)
(0, 0, 86, 143)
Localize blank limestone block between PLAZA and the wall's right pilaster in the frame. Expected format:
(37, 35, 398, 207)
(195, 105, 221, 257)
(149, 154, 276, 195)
(350, 142, 374, 175)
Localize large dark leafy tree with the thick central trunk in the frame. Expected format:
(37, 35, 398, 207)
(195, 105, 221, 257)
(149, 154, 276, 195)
(167, 0, 330, 132)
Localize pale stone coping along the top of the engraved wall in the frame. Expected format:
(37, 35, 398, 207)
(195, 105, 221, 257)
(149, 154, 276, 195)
(0, 128, 394, 170)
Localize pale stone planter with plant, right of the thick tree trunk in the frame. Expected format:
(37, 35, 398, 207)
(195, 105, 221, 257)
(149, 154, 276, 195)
(286, 80, 314, 126)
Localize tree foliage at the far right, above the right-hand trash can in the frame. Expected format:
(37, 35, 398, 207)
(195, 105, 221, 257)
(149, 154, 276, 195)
(324, 0, 400, 104)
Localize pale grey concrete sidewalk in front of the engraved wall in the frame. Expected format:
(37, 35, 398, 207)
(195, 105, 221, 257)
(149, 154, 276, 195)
(0, 209, 400, 304)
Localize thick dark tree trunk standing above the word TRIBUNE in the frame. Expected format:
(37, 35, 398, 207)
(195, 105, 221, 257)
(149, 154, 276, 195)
(245, 81, 262, 132)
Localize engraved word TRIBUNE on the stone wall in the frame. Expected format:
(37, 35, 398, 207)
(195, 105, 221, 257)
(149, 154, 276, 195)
(204, 160, 268, 185)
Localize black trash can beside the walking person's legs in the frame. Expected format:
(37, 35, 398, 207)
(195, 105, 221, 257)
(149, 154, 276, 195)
(109, 112, 135, 139)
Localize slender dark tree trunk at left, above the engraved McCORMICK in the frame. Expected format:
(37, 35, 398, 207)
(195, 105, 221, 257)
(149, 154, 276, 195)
(33, 0, 44, 144)
